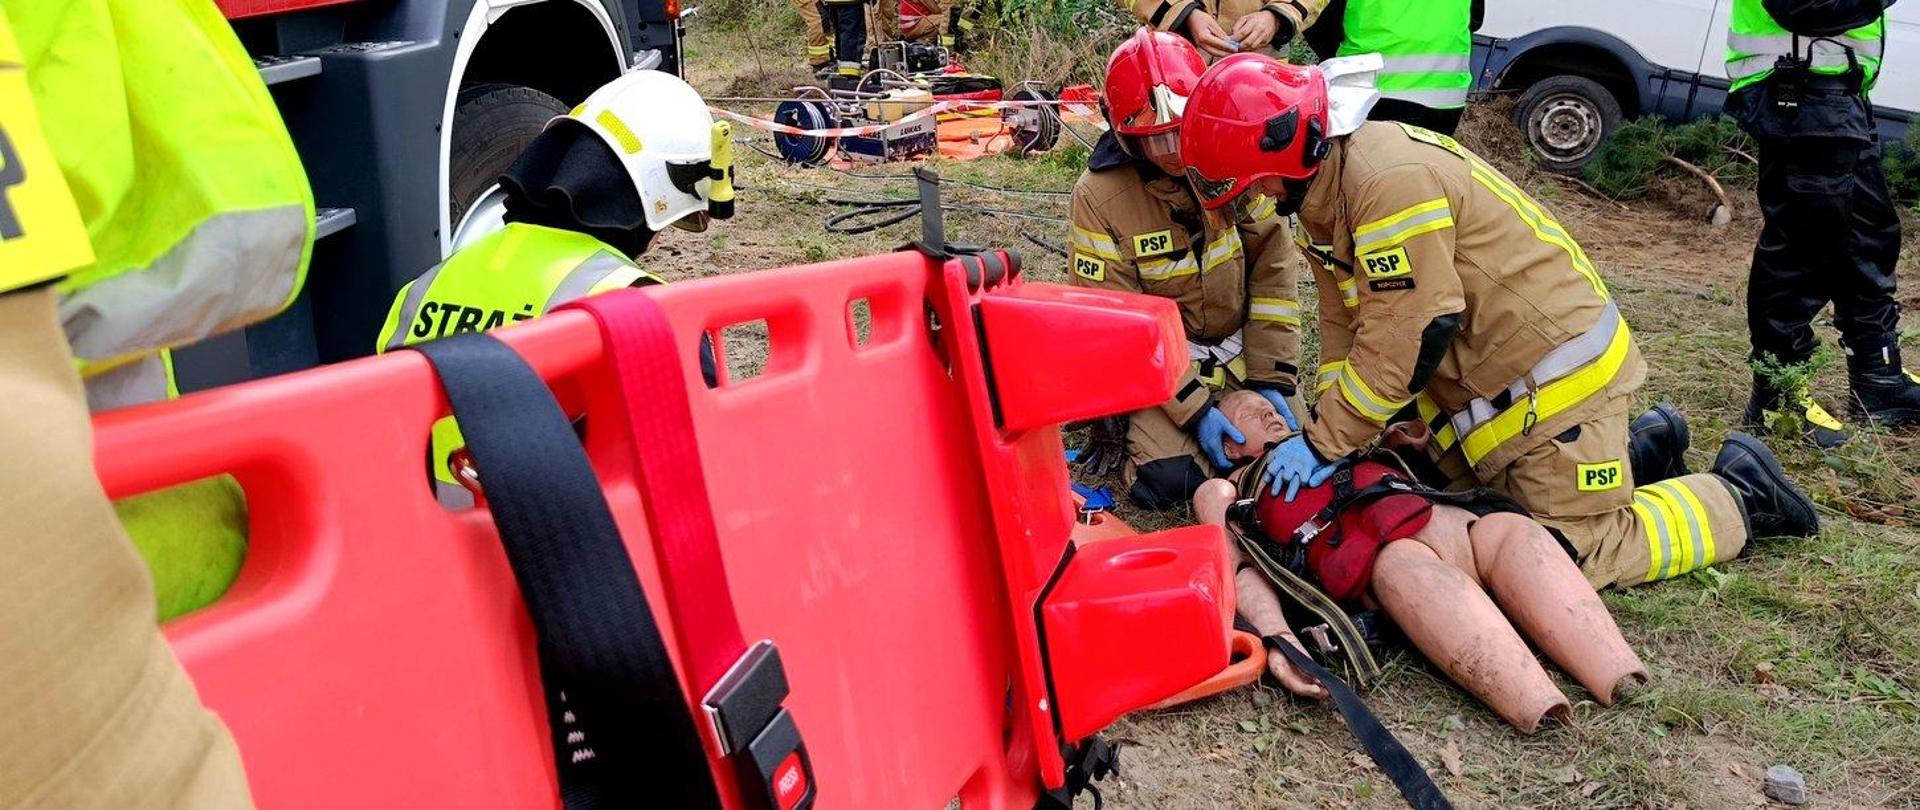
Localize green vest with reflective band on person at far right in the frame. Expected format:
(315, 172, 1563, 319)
(1726, 0, 1887, 90)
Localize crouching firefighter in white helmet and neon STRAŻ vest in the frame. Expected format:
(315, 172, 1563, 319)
(376, 71, 733, 507)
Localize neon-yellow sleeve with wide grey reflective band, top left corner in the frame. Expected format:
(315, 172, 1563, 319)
(0, 0, 313, 405)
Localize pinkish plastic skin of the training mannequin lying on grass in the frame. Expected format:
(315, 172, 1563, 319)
(1194, 392, 1647, 733)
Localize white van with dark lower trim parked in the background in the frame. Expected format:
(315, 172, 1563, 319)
(1473, 0, 1920, 171)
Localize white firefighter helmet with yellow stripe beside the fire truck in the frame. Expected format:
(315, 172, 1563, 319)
(568, 71, 714, 230)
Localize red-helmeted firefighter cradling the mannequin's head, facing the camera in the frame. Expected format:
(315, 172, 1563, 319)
(1069, 29, 1300, 509)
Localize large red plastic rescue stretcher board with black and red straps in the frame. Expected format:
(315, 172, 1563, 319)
(96, 234, 1233, 808)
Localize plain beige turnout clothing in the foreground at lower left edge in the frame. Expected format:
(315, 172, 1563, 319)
(0, 286, 252, 810)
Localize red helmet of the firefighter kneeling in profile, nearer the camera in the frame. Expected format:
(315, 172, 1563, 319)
(1181, 54, 1331, 209)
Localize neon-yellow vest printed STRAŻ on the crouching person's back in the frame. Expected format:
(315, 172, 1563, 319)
(376, 223, 660, 507)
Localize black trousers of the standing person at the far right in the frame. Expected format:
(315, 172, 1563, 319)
(1747, 91, 1901, 363)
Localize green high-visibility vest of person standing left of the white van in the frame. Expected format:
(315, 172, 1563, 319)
(1336, 0, 1473, 109)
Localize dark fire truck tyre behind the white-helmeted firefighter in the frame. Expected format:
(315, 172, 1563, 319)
(447, 84, 566, 223)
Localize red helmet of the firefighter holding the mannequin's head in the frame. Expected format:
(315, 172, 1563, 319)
(1102, 29, 1206, 146)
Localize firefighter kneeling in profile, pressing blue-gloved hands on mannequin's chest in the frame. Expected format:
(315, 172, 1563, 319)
(1181, 54, 1818, 587)
